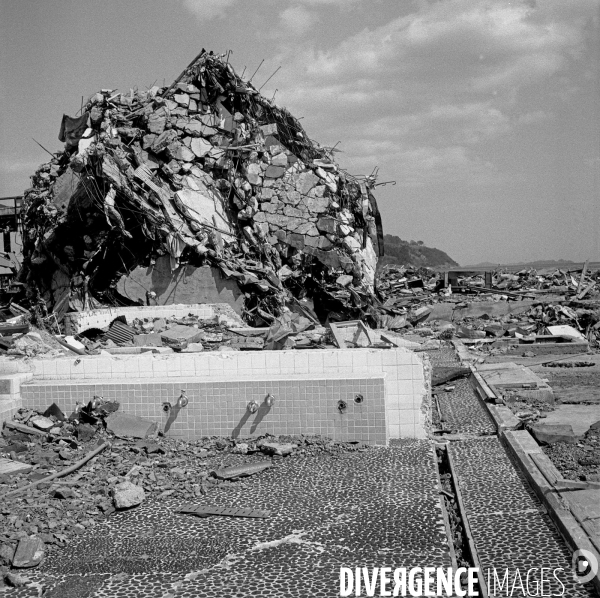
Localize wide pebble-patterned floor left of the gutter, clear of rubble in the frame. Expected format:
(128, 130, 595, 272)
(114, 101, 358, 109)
(1, 441, 451, 598)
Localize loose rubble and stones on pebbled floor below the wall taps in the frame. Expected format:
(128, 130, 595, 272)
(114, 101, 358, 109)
(0, 406, 369, 585)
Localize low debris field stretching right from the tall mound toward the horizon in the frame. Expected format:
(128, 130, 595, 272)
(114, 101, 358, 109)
(376, 264, 600, 357)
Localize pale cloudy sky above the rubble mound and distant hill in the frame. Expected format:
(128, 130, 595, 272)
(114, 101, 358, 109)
(0, 0, 600, 264)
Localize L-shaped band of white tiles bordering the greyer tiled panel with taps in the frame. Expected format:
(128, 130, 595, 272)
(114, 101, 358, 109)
(23, 348, 430, 438)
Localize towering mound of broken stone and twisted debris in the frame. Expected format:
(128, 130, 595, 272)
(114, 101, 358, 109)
(19, 50, 383, 325)
